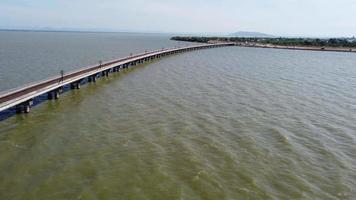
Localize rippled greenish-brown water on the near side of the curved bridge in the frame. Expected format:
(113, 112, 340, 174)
(0, 33, 356, 199)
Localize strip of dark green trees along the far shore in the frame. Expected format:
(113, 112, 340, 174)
(171, 36, 356, 48)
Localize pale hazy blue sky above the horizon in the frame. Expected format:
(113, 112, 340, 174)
(0, 0, 356, 36)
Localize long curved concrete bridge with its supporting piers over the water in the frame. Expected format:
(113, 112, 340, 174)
(0, 43, 234, 113)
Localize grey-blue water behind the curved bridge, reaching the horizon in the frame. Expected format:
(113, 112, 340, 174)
(0, 31, 190, 92)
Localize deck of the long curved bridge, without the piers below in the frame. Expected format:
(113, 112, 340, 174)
(0, 43, 233, 112)
